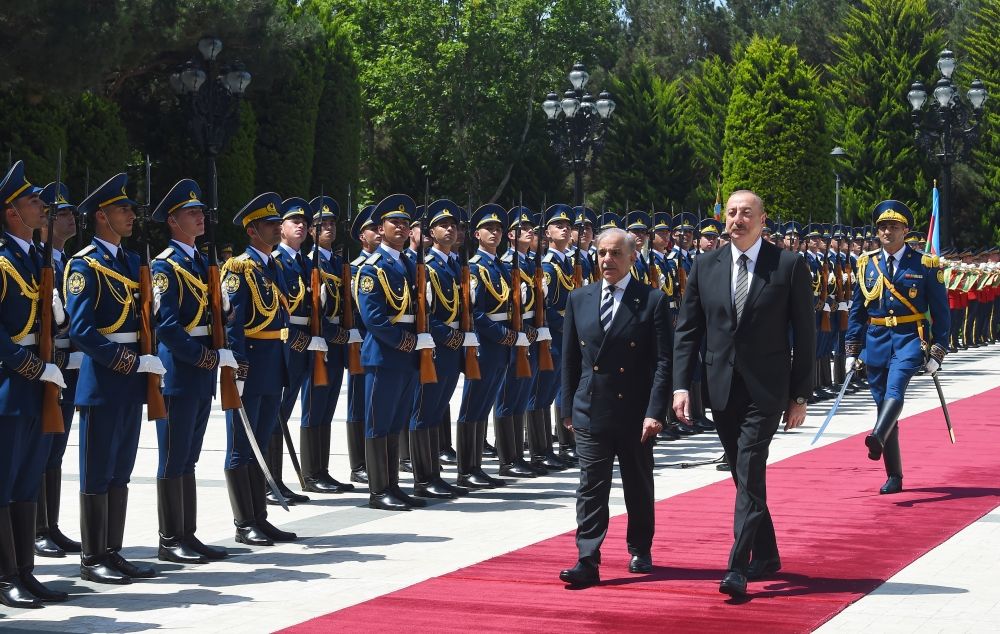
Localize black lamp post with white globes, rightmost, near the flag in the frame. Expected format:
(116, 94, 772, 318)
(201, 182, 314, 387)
(906, 49, 988, 247)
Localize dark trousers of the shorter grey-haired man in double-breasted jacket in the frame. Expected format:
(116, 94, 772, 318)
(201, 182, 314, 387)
(576, 426, 653, 565)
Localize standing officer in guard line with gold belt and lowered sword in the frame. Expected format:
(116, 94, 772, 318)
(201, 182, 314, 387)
(222, 192, 296, 546)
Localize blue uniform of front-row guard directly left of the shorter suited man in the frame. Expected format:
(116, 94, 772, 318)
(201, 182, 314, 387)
(528, 204, 576, 471)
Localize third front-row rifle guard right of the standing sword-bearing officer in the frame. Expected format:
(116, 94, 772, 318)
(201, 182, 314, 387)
(409, 199, 479, 499)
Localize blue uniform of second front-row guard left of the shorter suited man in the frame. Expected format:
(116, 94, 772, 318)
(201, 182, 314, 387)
(493, 207, 540, 478)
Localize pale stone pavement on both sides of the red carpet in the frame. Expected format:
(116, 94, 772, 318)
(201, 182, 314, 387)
(0, 346, 1000, 633)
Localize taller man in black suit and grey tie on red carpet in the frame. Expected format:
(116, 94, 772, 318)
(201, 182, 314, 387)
(673, 190, 816, 596)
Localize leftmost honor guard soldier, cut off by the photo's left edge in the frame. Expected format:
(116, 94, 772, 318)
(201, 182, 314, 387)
(0, 161, 68, 608)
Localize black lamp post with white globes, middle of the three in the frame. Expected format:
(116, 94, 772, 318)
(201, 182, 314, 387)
(542, 63, 615, 205)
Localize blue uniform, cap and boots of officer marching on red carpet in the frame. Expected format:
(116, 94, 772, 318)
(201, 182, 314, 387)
(846, 200, 951, 493)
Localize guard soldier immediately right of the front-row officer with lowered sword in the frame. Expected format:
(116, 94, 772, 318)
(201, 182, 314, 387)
(298, 196, 354, 493)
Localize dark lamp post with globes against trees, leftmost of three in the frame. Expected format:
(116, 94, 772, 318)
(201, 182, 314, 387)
(170, 36, 252, 227)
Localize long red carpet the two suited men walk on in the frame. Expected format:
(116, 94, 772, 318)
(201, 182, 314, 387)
(287, 388, 1000, 634)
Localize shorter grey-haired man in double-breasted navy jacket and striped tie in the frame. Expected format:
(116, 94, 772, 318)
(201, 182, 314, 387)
(559, 229, 673, 586)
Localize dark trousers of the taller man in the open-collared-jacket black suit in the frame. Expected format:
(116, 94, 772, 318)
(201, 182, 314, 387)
(712, 371, 781, 572)
